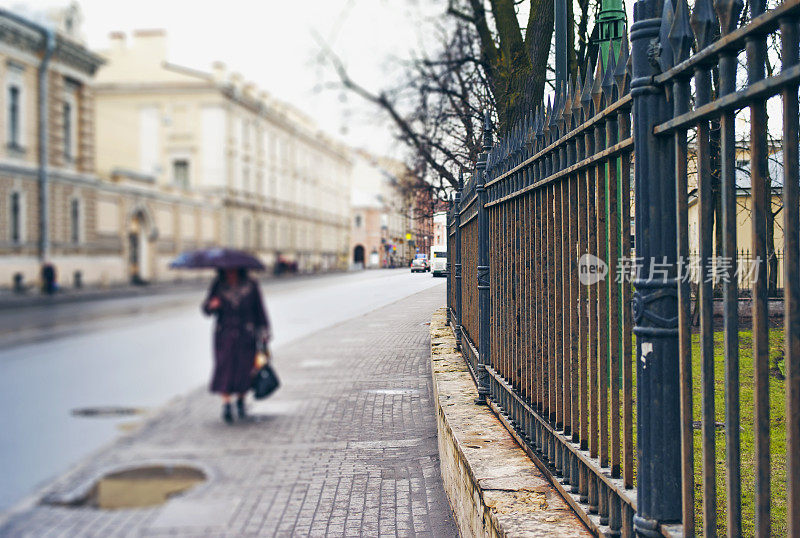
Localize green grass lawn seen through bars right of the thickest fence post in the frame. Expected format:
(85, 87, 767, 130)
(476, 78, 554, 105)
(692, 329, 787, 536)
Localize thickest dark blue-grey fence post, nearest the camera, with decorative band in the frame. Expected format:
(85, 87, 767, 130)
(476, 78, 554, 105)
(631, 0, 681, 536)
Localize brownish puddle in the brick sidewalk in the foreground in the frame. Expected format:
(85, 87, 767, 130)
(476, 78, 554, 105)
(53, 465, 206, 510)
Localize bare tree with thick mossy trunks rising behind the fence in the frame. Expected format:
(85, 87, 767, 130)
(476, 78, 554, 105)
(319, 0, 600, 199)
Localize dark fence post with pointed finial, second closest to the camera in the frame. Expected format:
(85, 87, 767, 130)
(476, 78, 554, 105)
(475, 112, 492, 403)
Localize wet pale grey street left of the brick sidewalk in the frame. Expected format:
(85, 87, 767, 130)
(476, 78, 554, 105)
(0, 269, 444, 511)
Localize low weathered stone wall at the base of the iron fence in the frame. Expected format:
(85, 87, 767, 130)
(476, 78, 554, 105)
(431, 308, 592, 537)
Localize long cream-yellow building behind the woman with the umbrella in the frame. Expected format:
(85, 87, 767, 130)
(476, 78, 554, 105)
(95, 30, 351, 272)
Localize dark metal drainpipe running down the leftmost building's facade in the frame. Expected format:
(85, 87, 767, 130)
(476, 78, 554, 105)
(38, 28, 56, 262)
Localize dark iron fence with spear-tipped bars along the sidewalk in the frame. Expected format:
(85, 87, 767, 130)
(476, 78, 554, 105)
(448, 0, 800, 536)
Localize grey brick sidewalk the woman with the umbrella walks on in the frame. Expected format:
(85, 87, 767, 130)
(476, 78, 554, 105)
(0, 286, 456, 537)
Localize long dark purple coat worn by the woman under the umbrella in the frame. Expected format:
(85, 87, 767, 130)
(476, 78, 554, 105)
(203, 278, 270, 394)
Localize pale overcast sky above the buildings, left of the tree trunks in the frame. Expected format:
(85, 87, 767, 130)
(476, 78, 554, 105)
(0, 0, 446, 157)
